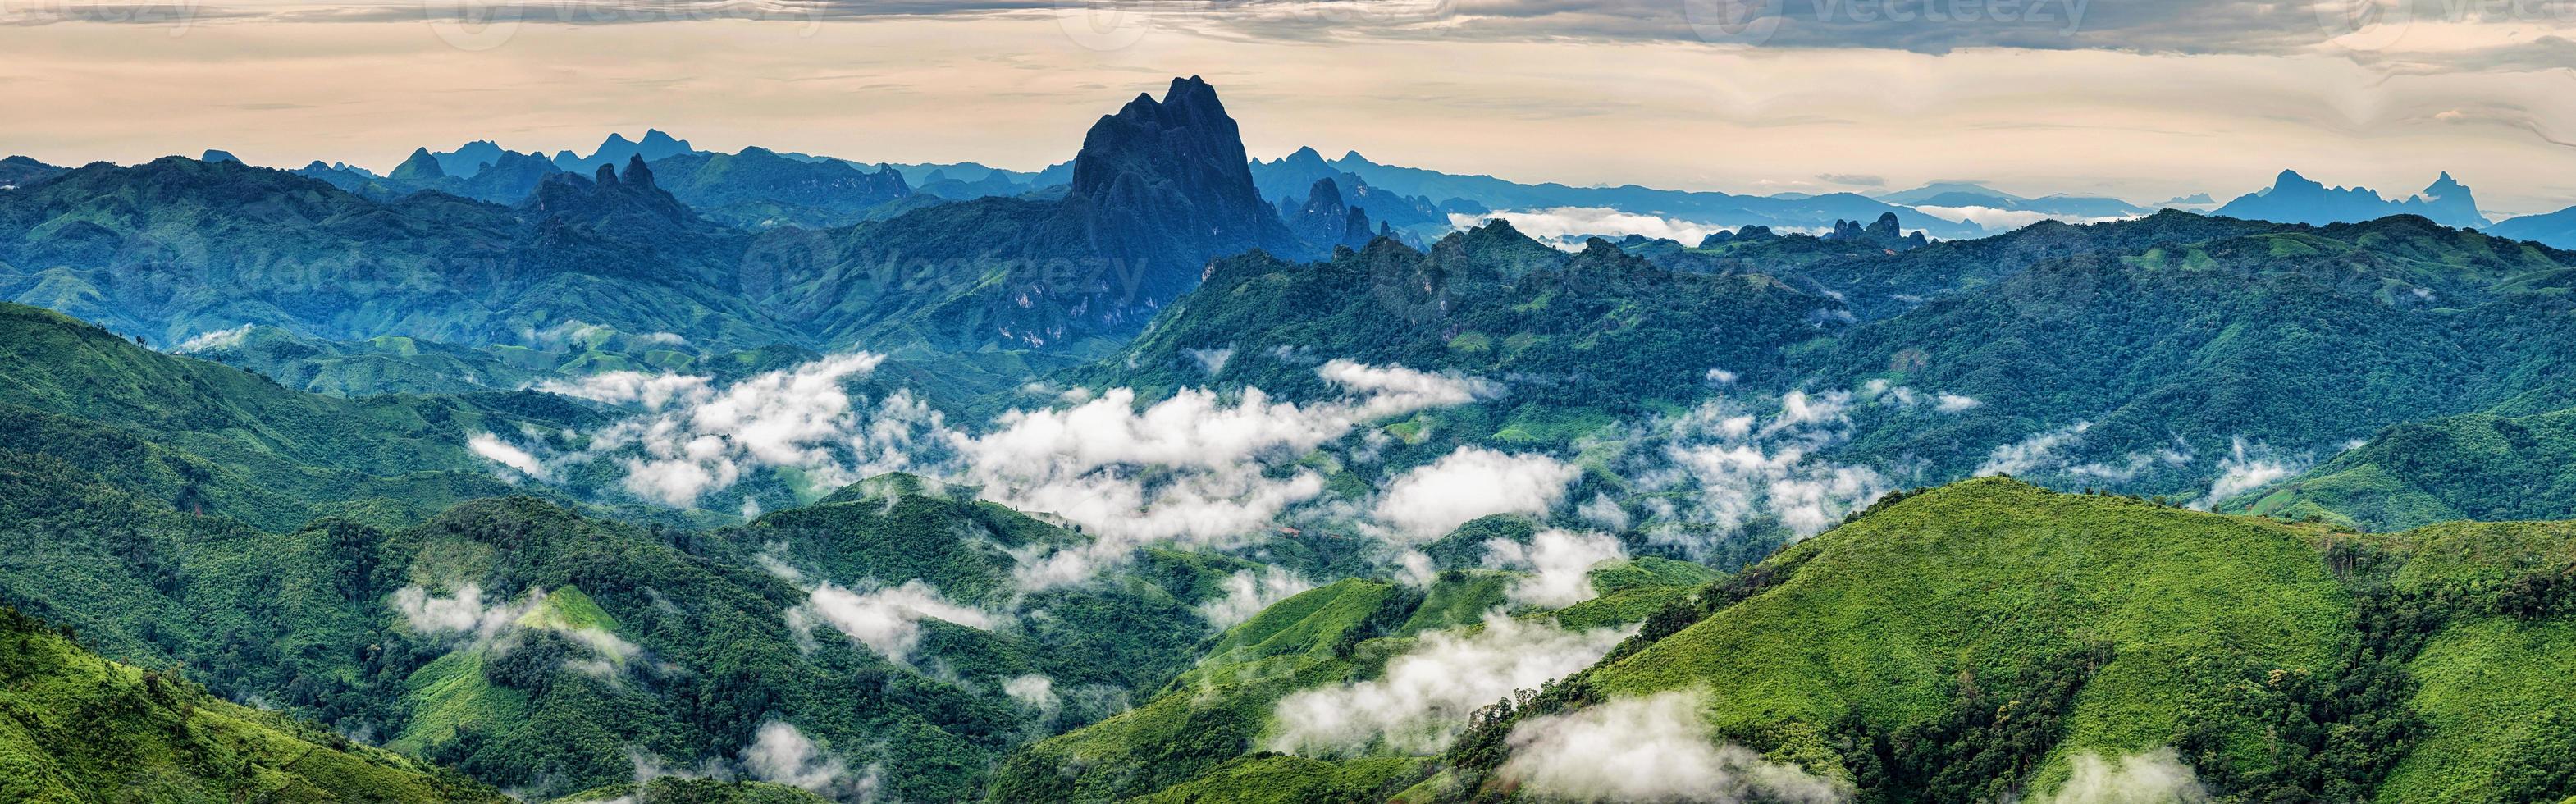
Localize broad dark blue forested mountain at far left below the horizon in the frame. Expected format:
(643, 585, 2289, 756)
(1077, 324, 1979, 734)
(0, 158, 796, 348)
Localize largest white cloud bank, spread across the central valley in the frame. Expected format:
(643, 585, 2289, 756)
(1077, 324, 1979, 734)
(505, 353, 1505, 590)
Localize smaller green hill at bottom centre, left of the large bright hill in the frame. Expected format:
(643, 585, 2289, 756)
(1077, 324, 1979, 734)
(987, 560, 1715, 804)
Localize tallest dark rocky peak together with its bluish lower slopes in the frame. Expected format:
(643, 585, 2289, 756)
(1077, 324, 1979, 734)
(742, 77, 1318, 350)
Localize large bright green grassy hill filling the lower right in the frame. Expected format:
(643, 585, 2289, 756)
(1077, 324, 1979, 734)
(1435, 479, 2576, 802)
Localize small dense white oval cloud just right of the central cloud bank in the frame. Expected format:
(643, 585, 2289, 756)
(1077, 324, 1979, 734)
(1373, 445, 1582, 541)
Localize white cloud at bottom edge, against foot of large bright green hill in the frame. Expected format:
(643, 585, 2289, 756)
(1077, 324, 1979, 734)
(1494, 693, 1850, 804)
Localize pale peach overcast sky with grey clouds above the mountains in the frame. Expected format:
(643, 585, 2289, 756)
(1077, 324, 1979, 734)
(0, 0, 2576, 214)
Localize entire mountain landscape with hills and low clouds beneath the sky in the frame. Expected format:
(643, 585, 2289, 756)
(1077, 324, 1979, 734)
(0, 77, 2576, 804)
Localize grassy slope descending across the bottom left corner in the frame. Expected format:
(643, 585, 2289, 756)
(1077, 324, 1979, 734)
(0, 608, 508, 804)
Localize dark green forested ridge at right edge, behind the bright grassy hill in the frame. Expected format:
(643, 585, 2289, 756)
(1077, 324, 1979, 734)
(1790, 217, 2576, 492)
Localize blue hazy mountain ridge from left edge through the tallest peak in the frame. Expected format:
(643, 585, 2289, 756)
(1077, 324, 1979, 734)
(0, 77, 1342, 363)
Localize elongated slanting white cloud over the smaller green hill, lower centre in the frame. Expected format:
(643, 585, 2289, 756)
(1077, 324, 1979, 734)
(1265, 614, 1633, 755)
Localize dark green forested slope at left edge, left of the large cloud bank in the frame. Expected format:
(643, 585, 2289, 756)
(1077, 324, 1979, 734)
(0, 304, 597, 531)
